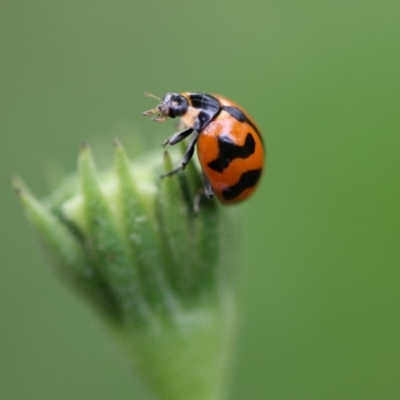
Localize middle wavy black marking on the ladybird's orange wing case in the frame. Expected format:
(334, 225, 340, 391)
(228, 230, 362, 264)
(207, 133, 256, 172)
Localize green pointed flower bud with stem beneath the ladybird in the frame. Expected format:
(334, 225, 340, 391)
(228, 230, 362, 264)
(13, 142, 238, 400)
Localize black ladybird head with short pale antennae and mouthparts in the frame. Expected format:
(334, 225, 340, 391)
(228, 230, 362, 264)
(143, 93, 189, 122)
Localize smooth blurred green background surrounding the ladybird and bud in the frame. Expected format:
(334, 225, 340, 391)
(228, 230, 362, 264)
(0, 0, 400, 400)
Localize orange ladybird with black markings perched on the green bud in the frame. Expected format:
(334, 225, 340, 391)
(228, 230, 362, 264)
(143, 92, 264, 204)
